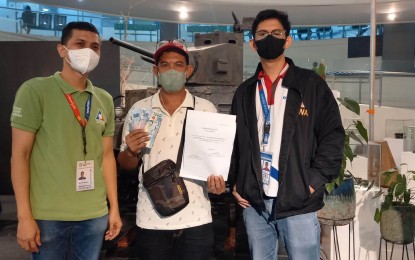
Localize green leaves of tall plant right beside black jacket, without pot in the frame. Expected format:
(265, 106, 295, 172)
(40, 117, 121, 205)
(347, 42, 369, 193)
(326, 97, 368, 193)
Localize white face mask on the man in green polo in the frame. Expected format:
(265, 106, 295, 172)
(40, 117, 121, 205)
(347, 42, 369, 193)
(63, 46, 100, 74)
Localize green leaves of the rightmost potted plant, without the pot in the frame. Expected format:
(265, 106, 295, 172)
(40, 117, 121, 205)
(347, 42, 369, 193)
(373, 164, 415, 223)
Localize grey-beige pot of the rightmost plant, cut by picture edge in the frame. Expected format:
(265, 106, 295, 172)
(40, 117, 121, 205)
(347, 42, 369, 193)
(380, 205, 415, 244)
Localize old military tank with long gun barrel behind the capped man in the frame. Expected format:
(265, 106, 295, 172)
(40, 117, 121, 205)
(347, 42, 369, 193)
(109, 31, 243, 113)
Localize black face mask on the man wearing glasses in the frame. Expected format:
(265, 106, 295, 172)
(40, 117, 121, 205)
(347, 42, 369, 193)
(255, 35, 285, 60)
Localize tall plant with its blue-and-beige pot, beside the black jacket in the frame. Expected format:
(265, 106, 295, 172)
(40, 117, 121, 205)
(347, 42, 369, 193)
(318, 98, 368, 226)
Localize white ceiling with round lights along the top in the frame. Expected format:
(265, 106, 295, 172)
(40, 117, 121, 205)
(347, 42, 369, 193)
(28, 0, 415, 26)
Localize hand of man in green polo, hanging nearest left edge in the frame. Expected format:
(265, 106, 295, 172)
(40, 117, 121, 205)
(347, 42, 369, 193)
(17, 218, 41, 253)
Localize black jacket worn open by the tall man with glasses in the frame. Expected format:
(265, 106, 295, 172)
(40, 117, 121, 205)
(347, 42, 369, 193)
(228, 58, 345, 219)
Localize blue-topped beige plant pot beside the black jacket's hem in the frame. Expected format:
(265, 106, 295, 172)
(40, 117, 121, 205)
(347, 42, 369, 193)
(317, 178, 356, 226)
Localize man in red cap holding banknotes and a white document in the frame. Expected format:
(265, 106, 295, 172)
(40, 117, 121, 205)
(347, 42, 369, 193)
(118, 40, 225, 260)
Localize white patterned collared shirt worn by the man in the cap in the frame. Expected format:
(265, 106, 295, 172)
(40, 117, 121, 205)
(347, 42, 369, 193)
(120, 90, 217, 230)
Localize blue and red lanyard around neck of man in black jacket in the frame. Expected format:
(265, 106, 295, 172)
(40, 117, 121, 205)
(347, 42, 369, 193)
(258, 63, 287, 145)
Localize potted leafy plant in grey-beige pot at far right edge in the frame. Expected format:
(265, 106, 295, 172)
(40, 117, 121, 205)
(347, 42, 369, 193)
(373, 164, 415, 244)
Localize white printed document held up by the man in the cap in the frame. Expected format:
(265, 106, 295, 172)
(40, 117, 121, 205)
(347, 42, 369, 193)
(180, 110, 236, 181)
